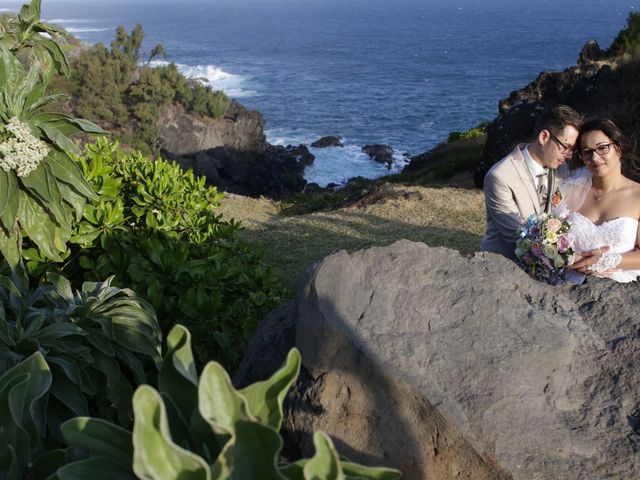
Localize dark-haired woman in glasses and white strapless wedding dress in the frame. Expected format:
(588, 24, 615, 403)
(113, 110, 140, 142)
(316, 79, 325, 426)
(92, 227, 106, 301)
(556, 119, 640, 282)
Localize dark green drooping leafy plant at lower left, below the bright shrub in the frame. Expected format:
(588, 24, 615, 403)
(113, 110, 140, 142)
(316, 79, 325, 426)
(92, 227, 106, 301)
(0, 272, 161, 438)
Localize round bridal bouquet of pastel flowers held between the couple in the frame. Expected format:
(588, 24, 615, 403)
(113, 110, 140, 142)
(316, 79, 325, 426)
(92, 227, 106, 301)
(516, 213, 573, 285)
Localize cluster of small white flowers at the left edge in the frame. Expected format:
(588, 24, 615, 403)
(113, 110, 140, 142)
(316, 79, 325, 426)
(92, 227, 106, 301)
(0, 117, 49, 177)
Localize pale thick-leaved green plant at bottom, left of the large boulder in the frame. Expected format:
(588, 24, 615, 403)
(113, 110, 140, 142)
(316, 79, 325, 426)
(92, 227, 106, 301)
(57, 325, 400, 480)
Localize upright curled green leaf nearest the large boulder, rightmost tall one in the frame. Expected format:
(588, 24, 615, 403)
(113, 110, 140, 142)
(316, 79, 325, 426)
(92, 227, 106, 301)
(240, 348, 301, 431)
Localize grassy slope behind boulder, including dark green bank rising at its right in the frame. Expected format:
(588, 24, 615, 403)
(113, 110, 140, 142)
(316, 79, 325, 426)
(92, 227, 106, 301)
(220, 138, 485, 286)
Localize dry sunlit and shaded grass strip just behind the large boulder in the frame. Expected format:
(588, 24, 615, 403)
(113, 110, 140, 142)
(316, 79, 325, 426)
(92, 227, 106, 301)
(220, 183, 485, 286)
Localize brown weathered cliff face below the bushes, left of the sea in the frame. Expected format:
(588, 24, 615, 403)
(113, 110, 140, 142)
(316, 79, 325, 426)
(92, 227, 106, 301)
(158, 101, 267, 156)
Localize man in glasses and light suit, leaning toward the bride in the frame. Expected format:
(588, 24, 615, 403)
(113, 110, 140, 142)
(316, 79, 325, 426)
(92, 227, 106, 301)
(480, 105, 582, 259)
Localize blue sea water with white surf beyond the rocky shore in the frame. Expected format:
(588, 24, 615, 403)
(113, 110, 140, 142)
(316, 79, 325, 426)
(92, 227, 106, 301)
(0, 0, 639, 185)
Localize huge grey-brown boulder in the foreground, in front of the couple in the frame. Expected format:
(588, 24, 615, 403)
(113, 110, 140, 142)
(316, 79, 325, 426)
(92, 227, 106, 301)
(239, 241, 640, 480)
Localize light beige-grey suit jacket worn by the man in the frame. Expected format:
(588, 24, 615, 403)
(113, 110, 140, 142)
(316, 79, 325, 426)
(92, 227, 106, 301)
(480, 144, 567, 259)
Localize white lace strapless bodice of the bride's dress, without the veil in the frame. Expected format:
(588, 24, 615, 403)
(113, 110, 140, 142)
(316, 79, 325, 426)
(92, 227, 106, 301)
(567, 212, 640, 282)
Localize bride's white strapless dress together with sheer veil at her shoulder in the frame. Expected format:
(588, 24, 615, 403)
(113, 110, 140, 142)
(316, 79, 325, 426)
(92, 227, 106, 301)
(554, 169, 640, 283)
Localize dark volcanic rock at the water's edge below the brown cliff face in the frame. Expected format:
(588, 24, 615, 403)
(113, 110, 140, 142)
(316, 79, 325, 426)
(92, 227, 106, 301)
(173, 145, 314, 199)
